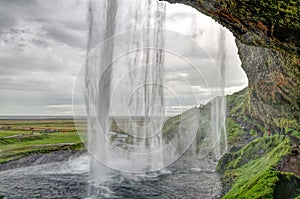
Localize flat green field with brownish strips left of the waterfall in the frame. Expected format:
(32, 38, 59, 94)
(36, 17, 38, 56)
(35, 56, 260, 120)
(0, 119, 84, 163)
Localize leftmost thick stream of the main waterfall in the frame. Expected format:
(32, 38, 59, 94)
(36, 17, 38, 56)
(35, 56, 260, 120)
(85, 0, 118, 175)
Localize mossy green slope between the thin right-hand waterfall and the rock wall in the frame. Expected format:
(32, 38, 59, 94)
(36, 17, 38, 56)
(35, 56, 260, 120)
(226, 88, 299, 147)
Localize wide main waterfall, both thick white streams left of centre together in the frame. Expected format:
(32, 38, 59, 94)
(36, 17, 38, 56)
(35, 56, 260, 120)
(85, 0, 169, 176)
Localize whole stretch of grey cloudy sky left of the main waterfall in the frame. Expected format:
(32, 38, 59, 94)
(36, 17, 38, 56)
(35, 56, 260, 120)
(0, 0, 87, 114)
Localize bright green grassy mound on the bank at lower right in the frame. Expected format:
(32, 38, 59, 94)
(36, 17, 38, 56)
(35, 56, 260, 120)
(217, 136, 291, 199)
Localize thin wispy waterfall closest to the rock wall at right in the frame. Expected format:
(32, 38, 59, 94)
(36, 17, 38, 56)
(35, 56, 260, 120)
(190, 10, 228, 160)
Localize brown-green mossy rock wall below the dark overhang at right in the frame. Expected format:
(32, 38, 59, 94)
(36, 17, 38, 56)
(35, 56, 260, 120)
(236, 41, 300, 129)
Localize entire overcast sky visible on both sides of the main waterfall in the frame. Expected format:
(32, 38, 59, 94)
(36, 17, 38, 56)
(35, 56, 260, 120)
(0, 0, 247, 115)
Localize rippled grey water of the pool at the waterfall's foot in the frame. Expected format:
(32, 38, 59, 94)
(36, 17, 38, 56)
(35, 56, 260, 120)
(0, 155, 221, 199)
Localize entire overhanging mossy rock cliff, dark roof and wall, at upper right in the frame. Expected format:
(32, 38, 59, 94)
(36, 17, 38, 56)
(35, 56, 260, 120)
(163, 0, 300, 130)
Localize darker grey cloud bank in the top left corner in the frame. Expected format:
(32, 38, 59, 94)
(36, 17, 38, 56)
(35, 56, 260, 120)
(0, 0, 88, 49)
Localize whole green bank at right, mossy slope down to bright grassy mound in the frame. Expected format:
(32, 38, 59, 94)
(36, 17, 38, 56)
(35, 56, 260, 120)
(217, 88, 300, 198)
